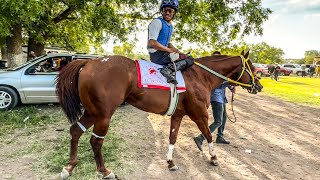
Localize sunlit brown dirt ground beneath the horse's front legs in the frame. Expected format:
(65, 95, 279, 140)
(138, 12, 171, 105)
(0, 90, 320, 180)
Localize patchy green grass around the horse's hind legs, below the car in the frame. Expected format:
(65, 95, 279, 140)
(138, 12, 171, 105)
(0, 105, 127, 180)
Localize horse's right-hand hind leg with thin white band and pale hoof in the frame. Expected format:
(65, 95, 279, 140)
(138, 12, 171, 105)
(90, 116, 115, 179)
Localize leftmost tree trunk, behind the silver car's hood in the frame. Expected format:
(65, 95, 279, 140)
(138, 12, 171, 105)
(6, 24, 24, 68)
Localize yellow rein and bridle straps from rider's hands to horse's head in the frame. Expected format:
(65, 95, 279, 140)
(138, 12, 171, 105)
(194, 55, 254, 87)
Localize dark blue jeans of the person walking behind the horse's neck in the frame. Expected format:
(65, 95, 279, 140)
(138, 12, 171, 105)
(198, 101, 227, 141)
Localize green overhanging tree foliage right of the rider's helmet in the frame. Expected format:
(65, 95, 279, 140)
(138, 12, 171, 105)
(175, 0, 271, 48)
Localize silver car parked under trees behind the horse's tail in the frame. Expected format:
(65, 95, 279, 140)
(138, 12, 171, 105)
(0, 53, 102, 110)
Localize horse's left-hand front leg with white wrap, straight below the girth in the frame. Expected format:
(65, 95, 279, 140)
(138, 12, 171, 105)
(167, 115, 183, 171)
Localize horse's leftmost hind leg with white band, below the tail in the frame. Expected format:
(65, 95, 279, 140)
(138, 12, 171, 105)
(61, 111, 93, 179)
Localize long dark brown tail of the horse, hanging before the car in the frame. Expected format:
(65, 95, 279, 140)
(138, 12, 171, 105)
(56, 60, 88, 124)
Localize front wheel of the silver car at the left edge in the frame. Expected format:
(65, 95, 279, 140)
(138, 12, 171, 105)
(0, 86, 19, 110)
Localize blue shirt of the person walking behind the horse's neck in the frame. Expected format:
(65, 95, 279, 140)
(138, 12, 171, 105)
(210, 81, 233, 104)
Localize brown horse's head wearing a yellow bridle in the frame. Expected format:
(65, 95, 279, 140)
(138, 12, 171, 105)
(235, 51, 263, 94)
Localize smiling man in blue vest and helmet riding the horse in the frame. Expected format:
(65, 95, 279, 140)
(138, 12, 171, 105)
(147, 0, 194, 84)
